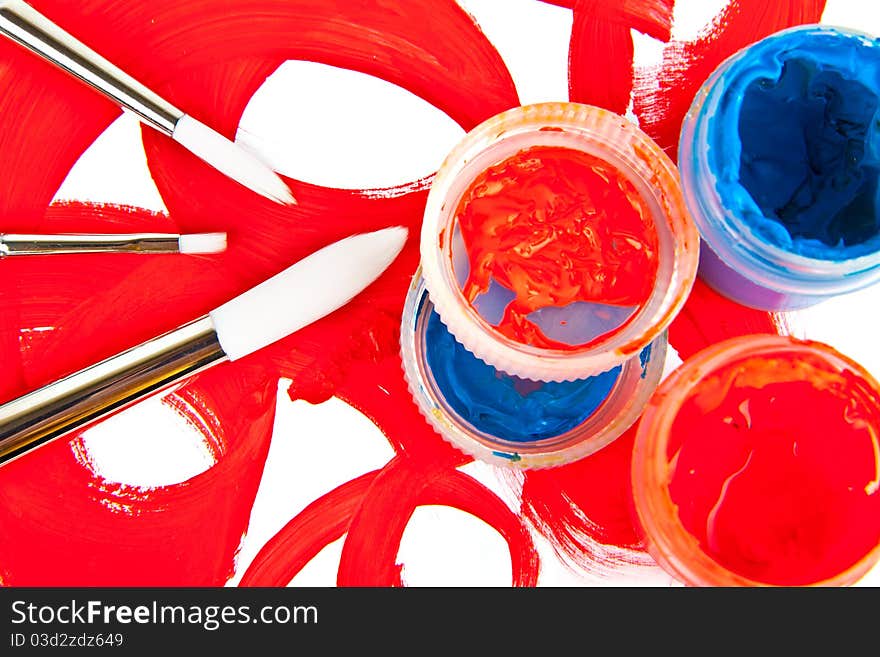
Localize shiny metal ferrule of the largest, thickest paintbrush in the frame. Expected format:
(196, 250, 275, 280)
(0, 316, 226, 465)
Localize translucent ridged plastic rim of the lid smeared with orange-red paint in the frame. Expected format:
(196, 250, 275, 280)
(421, 103, 699, 381)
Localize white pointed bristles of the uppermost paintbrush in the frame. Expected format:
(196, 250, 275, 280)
(172, 114, 296, 205)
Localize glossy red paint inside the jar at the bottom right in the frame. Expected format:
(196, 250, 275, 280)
(668, 351, 880, 586)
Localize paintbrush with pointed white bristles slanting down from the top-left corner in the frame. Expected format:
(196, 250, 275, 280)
(0, 0, 296, 204)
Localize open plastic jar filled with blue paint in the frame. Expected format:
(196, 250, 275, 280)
(679, 25, 880, 311)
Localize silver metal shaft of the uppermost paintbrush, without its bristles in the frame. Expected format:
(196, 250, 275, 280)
(0, 0, 184, 137)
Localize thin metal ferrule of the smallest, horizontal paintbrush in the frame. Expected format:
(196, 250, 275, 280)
(0, 233, 180, 257)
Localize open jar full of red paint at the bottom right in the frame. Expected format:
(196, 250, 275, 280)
(632, 335, 880, 586)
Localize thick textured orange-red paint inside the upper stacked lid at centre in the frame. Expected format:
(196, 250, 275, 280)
(453, 146, 658, 351)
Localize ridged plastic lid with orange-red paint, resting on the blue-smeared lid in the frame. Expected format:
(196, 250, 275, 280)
(421, 103, 699, 381)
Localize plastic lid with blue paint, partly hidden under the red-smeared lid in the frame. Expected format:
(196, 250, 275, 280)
(400, 272, 667, 469)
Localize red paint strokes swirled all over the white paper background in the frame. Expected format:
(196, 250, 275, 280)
(0, 0, 824, 585)
